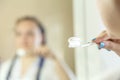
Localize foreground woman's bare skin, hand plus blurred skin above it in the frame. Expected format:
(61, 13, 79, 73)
(93, 0, 120, 56)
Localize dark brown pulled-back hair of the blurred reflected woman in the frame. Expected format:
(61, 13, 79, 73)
(16, 16, 46, 45)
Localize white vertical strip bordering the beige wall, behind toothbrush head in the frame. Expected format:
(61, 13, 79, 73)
(73, 0, 87, 80)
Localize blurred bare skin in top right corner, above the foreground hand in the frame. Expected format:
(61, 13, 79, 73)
(97, 0, 120, 38)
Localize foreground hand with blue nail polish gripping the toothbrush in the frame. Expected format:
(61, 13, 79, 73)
(93, 31, 120, 56)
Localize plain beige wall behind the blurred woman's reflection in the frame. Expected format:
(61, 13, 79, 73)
(0, 0, 74, 70)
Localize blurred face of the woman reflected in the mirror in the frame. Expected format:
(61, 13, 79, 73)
(15, 20, 42, 51)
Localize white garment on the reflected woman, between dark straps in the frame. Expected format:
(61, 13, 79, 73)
(0, 59, 60, 80)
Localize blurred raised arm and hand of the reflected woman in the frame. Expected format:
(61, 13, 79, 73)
(40, 46, 76, 80)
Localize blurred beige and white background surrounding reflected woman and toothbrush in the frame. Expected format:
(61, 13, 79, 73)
(0, 0, 120, 80)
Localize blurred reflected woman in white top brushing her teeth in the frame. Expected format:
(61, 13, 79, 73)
(0, 16, 75, 80)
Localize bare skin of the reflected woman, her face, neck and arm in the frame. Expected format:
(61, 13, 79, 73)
(15, 20, 70, 80)
